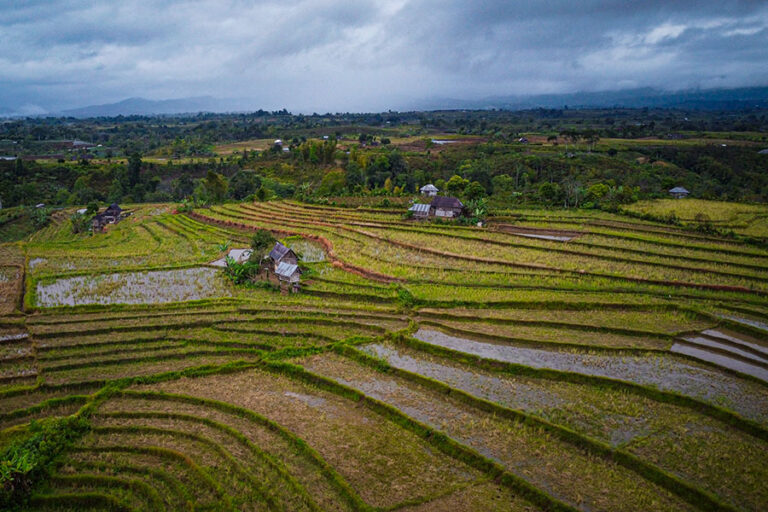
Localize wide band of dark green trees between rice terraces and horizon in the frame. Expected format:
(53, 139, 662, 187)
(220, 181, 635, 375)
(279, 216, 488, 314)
(0, 109, 768, 212)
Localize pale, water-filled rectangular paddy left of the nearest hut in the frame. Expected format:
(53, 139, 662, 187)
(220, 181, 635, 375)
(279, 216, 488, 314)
(37, 267, 229, 307)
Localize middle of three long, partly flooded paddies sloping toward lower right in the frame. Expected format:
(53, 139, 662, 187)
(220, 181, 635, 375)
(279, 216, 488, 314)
(356, 344, 768, 506)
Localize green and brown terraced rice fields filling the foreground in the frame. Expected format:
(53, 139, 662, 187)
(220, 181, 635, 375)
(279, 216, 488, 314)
(0, 201, 768, 512)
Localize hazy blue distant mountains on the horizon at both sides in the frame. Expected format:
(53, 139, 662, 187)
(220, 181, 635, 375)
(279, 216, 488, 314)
(0, 87, 768, 118)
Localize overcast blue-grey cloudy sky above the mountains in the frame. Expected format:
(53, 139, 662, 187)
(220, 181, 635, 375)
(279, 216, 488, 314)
(0, 0, 768, 113)
